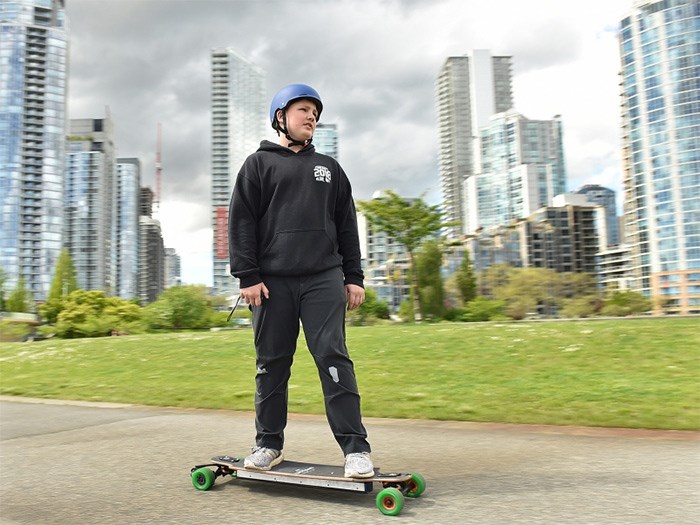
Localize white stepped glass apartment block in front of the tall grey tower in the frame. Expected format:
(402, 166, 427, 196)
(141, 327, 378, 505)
(463, 110, 566, 234)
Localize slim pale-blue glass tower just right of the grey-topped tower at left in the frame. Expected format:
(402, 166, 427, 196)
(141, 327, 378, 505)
(114, 158, 141, 300)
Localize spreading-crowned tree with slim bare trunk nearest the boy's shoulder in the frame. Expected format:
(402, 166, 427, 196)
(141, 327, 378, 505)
(358, 190, 448, 321)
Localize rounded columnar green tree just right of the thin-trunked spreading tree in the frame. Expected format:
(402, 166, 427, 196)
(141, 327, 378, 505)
(416, 239, 445, 319)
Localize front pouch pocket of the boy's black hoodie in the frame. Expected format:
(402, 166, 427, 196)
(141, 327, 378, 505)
(260, 230, 341, 275)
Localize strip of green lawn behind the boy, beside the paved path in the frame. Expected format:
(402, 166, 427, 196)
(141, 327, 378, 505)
(0, 318, 700, 430)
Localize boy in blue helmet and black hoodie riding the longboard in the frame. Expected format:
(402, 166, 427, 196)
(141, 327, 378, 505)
(229, 84, 374, 478)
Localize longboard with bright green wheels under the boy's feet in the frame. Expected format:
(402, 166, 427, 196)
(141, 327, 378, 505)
(190, 456, 426, 516)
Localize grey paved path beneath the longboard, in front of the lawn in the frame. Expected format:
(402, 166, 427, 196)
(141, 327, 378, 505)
(0, 397, 700, 525)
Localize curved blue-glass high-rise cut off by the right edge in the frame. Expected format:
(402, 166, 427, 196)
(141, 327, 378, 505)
(619, 0, 700, 313)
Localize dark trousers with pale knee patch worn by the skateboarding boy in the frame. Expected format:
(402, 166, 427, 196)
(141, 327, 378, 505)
(252, 268, 370, 455)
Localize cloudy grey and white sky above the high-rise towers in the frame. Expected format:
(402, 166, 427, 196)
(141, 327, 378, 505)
(66, 0, 633, 285)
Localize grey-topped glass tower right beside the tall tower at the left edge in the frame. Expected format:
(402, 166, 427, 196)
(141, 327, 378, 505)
(63, 117, 116, 295)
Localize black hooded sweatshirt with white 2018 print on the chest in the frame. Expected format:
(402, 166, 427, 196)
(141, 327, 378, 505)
(228, 140, 364, 288)
